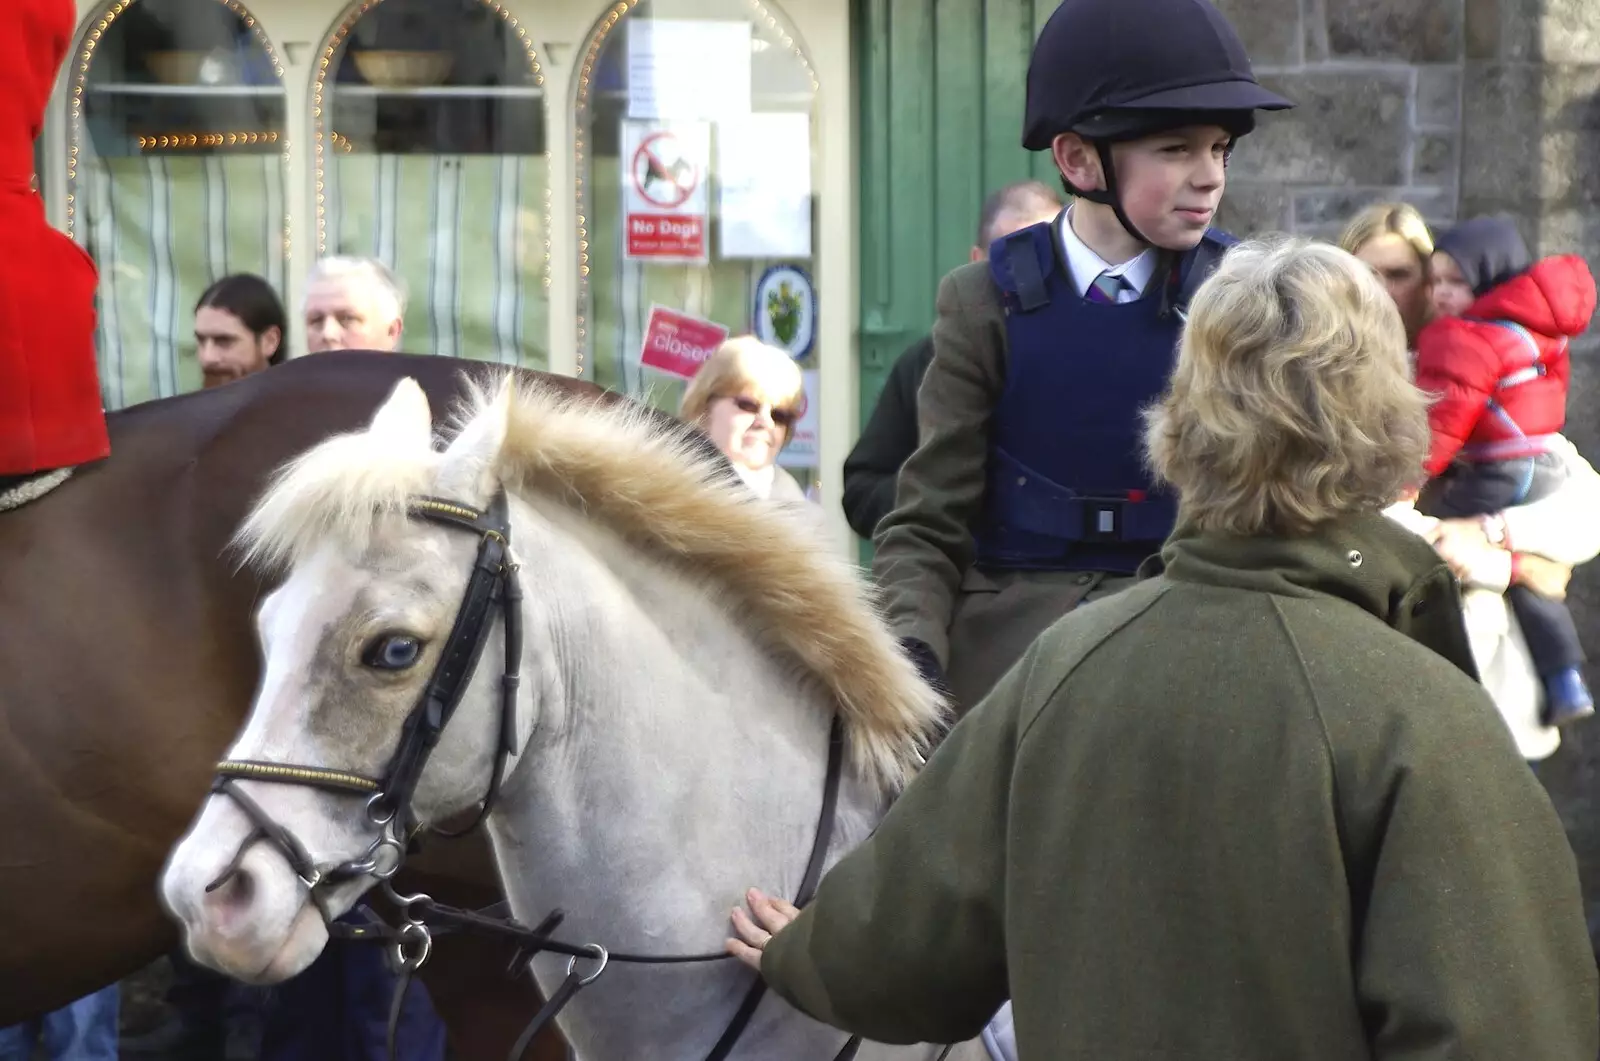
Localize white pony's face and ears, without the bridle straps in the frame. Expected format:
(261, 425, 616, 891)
(162, 377, 518, 983)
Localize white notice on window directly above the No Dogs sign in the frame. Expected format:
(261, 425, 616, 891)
(627, 19, 750, 122)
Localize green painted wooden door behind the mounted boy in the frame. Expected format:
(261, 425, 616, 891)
(853, 0, 1059, 555)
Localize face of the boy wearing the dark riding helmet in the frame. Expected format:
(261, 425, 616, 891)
(1110, 125, 1234, 251)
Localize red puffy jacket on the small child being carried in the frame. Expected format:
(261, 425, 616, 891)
(1416, 254, 1595, 475)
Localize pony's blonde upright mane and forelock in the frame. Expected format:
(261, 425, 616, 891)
(237, 376, 946, 789)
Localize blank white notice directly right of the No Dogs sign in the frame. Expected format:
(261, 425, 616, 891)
(715, 114, 811, 258)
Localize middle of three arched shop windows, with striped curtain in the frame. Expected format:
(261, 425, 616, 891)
(312, 0, 550, 370)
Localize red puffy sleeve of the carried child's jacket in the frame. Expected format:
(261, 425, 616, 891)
(1416, 318, 1501, 475)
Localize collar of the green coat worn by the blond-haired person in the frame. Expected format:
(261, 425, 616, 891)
(1139, 514, 1478, 680)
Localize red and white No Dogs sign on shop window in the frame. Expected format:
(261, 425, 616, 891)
(622, 122, 710, 261)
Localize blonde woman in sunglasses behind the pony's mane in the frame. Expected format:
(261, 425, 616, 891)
(678, 336, 806, 501)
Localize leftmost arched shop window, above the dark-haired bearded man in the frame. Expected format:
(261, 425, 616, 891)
(67, 0, 288, 408)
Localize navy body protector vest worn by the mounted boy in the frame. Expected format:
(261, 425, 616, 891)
(974, 211, 1237, 575)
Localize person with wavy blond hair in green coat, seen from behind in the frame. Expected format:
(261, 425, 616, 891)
(728, 240, 1600, 1061)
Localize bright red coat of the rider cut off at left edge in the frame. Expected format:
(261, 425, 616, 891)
(0, 0, 110, 475)
